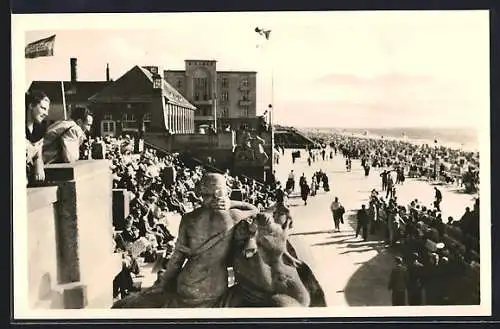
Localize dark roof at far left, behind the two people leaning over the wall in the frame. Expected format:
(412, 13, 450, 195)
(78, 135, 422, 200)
(28, 81, 111, 104)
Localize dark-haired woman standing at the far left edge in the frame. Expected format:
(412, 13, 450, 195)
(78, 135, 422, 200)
(25, 90, 50, 184)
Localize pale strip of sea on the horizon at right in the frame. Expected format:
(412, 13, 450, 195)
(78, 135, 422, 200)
(306, 128, 479, 152)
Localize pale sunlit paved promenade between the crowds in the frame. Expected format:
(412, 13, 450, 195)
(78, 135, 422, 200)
(276, 150, 474, 306)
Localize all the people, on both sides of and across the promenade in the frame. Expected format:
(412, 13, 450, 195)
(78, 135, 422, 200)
(26, 91, 479, 305)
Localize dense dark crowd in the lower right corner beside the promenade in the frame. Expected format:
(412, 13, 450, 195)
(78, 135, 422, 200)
(380, 192, 479, 305)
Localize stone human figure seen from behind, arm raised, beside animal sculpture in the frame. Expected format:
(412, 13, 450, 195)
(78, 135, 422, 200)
(114, 174, 258, 308)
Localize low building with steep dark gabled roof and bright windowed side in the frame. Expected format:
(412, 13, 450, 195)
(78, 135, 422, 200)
(89, 66, 196, 136)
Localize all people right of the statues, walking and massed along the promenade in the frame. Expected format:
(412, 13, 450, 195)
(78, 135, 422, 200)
(287, 138, 480, 305)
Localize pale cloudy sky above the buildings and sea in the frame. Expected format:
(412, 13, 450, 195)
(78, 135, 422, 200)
(17, 11, 490, 128)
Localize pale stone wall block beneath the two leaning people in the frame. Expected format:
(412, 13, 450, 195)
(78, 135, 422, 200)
(28, 160, 121, 308)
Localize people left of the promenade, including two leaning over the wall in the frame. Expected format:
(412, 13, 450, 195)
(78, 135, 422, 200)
(25, 87, 282, 297)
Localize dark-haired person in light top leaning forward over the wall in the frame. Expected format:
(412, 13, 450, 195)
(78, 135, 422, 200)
(43, 107, 93, 164)
